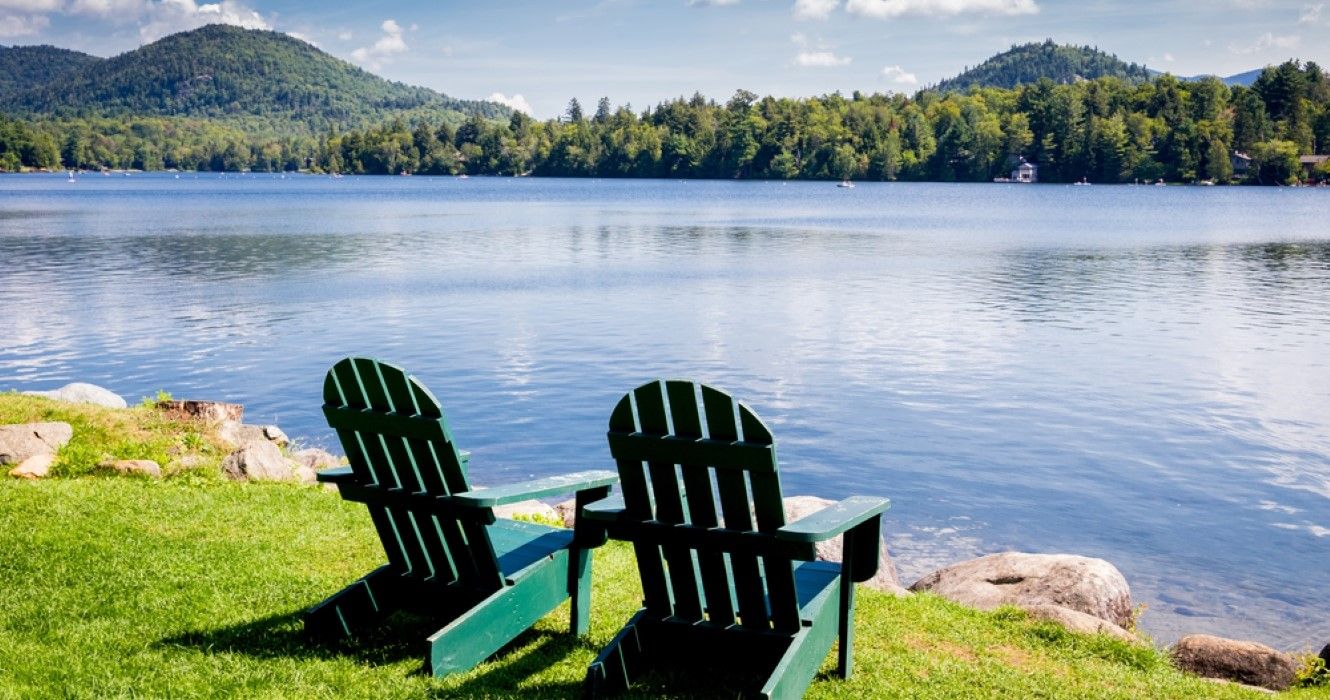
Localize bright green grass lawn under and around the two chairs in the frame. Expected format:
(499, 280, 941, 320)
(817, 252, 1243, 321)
(0, 395, 1330, 699)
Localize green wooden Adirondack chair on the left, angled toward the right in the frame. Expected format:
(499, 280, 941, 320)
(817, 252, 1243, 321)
(305, 358, 617, 676)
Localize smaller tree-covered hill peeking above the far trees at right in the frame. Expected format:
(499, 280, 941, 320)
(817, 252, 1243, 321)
(938, 40, 1150, 92)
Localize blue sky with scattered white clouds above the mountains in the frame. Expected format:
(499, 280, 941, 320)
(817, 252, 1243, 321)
(0, 0, 1330, 117)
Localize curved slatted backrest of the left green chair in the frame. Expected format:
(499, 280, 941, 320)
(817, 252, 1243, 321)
(323, 357, 503, 590)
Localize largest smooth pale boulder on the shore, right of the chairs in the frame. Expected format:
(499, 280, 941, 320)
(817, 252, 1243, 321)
(910, 552, 1132, 628)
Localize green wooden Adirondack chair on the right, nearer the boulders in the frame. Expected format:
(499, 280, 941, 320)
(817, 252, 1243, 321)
(577, 381, 888, 697)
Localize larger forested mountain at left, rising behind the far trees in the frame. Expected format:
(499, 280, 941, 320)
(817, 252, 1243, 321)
(0, 24, 511, 132)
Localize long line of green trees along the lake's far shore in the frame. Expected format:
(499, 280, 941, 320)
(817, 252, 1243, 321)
(0, 61, 1330, 184)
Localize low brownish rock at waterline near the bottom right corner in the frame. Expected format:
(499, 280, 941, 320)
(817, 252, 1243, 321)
(1169, 635, 1298, 691)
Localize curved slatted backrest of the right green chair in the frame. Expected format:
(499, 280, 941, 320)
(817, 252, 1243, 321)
(609, 381, 799, 632)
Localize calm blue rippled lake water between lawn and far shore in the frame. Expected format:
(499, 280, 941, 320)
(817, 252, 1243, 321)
(0, 174, 1330, 649)
